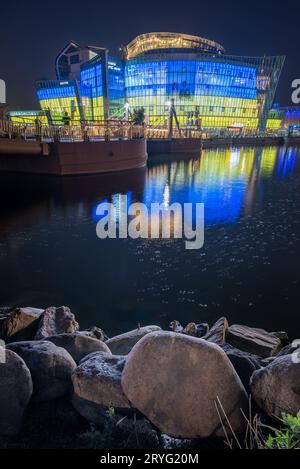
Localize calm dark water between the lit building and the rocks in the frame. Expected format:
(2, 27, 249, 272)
(0, 147, 300, 337)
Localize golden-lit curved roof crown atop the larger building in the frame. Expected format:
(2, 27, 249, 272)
(125, 33, 225, 60)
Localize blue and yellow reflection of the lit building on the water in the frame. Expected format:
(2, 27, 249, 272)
(102, 147, 297, 231)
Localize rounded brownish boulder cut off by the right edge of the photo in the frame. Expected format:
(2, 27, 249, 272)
(250, 354, 300, 417)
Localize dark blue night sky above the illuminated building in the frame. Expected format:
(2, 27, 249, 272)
(0, 0, 300, 109)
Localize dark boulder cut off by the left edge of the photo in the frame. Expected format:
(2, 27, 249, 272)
(0, 349, 32, 435)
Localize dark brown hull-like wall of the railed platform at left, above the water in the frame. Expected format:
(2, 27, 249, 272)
(0, 139, 147, 176)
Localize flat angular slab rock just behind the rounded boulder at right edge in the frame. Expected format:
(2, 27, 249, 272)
(226, 324, 282, 358)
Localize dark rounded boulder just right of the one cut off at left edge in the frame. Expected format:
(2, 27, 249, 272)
(7, 340, 76, 401)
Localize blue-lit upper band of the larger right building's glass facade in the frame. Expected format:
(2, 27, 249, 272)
(125, 60, 257, 99)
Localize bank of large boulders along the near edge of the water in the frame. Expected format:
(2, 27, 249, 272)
(0, 306, 300, 447)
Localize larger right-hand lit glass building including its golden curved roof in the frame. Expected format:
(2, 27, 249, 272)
(125, 33, 284, 130)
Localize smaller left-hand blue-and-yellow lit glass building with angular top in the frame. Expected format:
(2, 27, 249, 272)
(36, 42, 125, 125)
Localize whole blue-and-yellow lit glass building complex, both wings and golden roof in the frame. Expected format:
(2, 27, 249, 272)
(37, 33, 284, 131)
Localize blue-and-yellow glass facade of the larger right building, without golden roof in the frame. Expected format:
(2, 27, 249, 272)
(125, 54, 282, 129)
